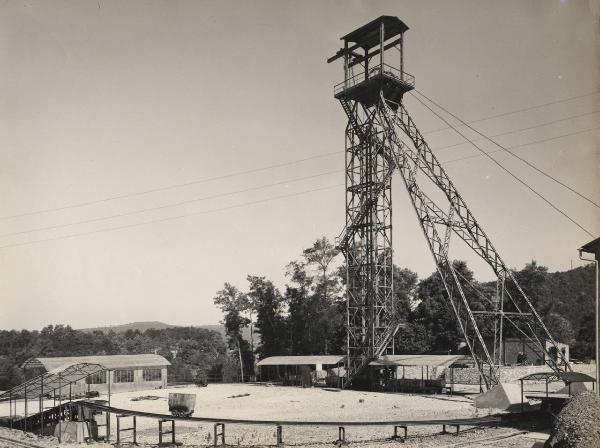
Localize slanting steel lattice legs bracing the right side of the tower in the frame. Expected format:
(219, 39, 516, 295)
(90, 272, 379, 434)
(378, 96, 570, 387)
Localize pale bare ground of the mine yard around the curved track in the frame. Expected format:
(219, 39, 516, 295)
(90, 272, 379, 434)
(0, 384, 544, 448)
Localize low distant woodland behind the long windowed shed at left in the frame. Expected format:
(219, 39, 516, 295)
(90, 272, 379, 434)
(0, 325, 234, 390)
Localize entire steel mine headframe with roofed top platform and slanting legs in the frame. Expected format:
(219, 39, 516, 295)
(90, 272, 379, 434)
(327, 16, 570, 388)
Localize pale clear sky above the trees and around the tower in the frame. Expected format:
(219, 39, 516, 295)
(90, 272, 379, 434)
(0, 0, 600, 329)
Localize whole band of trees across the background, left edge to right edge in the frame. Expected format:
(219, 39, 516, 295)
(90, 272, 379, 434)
(0, 238, 595, 390)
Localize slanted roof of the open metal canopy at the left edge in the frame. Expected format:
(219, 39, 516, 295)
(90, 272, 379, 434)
(0, 363, 106, 400)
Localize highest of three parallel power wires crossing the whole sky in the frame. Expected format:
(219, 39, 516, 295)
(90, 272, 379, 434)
(0, 91, 600, 220)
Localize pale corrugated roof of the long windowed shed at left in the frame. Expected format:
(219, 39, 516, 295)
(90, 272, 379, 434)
(22, 354, 171, 372)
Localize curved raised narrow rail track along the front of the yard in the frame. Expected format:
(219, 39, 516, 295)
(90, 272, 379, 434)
(77, 401, 501, 426)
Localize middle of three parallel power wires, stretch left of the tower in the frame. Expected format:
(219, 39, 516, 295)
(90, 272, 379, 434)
(0, 170, 342, 238)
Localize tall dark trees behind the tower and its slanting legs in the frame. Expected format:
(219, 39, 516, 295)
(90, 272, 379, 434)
(214, 238, 594, 376)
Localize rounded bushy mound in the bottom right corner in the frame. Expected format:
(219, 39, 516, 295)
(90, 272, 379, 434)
(544, 392, 600, 448)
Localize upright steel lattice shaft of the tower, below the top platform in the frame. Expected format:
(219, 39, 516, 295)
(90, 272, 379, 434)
(338, 101, 398, 386)
